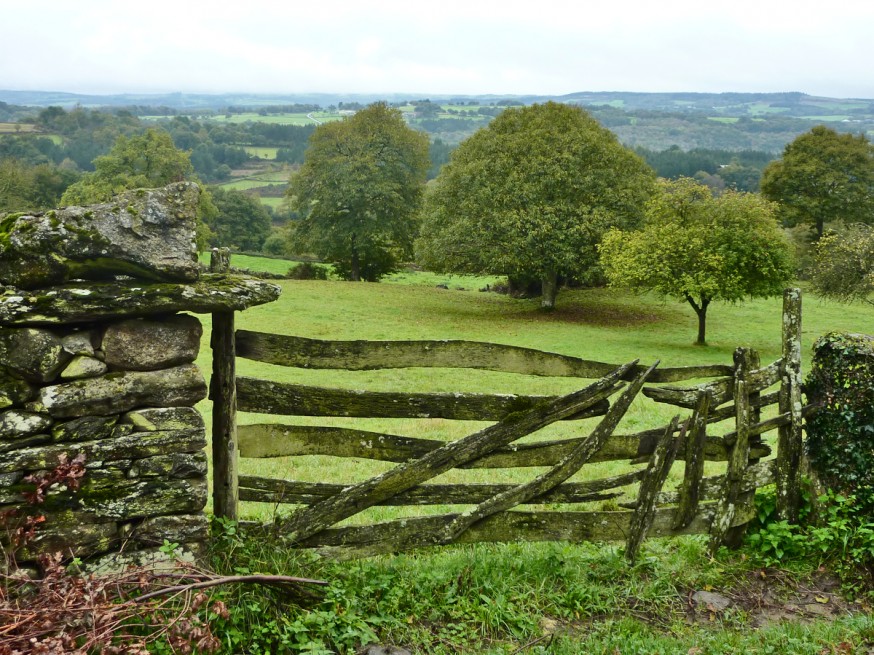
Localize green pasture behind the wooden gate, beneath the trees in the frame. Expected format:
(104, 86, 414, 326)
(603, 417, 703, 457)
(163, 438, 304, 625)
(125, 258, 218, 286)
(192, 256, 874, 522)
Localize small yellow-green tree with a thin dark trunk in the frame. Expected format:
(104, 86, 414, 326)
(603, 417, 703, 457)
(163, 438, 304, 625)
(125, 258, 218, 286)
(600, 178, 793, 345)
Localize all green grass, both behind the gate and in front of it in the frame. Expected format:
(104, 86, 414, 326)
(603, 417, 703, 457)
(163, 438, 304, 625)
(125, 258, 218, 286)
(199, 256, 874, 655)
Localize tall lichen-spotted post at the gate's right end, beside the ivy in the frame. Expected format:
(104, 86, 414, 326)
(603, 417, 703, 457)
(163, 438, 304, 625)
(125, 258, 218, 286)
(777, 289, 803, 523)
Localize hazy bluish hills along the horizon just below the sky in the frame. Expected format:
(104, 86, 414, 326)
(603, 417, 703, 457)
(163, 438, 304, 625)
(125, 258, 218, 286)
(0, 90, 874, 154)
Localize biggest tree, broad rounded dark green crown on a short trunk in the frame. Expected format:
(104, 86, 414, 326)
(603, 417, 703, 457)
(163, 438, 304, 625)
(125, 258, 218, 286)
(417, 102, 655, 308)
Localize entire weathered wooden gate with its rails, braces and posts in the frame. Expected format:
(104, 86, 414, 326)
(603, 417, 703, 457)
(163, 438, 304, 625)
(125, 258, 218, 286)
(213, 289, 809, 559)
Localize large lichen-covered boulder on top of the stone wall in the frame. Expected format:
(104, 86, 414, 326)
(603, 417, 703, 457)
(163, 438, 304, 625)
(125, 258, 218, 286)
(0, 182, 200, 289)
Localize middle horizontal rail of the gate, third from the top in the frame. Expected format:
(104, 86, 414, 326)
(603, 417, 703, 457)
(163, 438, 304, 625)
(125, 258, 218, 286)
(237, 417, 768, 469)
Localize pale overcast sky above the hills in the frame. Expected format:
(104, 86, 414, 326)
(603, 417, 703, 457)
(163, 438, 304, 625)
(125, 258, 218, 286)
(0, 0, 874, 98)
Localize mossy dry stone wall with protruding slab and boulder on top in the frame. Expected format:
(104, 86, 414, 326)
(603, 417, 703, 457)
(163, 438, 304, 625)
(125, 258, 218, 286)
(0, 183, 279, 565)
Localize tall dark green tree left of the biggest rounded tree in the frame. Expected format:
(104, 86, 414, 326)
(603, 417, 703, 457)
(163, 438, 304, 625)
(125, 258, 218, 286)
(288, 102, 430, 281)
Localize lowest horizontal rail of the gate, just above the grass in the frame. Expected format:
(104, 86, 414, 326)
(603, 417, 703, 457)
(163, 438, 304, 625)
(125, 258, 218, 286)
(292, 505, 754, 558)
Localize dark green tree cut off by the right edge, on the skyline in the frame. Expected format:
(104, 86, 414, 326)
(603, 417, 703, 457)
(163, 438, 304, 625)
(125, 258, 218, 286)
(761, 125, 874, 237)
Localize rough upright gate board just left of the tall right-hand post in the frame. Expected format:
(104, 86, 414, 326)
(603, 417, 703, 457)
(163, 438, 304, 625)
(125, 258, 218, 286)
(710, 348, 752, 553)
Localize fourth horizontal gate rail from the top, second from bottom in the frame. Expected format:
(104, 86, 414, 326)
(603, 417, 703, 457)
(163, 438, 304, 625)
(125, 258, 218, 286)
(240, 470, 643, 507)
